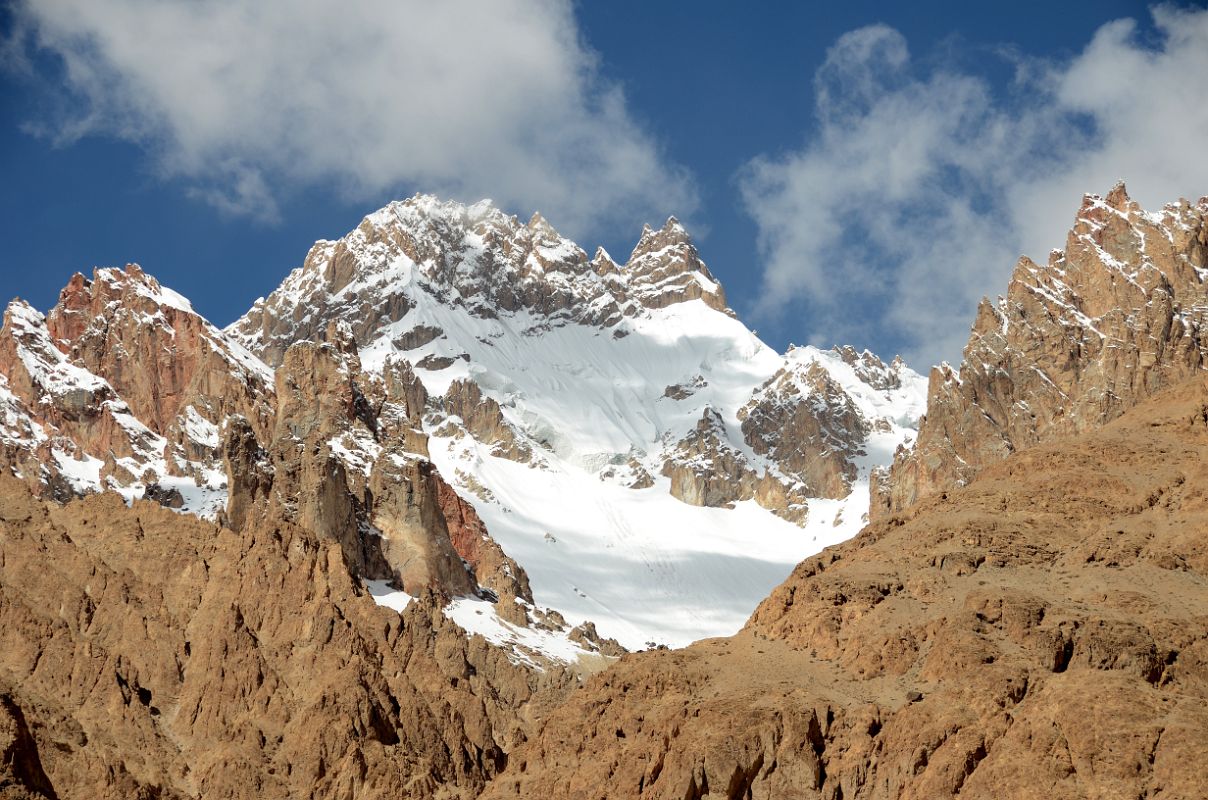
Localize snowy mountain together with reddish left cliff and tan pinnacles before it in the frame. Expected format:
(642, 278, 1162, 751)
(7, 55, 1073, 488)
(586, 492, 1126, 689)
(0, 196, 925, 661)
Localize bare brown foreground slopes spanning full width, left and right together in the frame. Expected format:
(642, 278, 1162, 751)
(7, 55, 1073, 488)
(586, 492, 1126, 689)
(0, 364, 1208, 800)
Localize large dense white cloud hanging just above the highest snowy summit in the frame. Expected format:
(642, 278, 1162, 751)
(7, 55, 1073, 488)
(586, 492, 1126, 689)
(9, 0, 696, 232)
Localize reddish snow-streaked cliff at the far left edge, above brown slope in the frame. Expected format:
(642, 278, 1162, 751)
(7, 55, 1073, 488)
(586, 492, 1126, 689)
(0, 265, 274, 516)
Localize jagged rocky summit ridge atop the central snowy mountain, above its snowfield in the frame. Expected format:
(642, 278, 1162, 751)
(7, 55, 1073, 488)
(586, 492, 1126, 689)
(227, 195, 731, 372)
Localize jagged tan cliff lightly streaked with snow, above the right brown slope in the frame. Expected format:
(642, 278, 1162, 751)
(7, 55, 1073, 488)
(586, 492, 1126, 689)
(872, 185, 1208, 516)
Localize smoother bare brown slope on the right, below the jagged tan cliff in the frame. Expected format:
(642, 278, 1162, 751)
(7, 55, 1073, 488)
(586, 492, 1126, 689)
(483, 378, 1208, 800)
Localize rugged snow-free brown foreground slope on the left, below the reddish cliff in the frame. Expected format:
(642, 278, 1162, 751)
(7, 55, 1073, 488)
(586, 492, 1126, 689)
(0, 476, 571, 800)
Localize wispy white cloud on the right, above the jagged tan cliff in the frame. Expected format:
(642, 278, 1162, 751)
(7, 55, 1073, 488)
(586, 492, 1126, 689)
(741, 7, 1208, 365)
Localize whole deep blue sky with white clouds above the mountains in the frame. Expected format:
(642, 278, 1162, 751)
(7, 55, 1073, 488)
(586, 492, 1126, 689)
(0, 0, 1208, 367)
